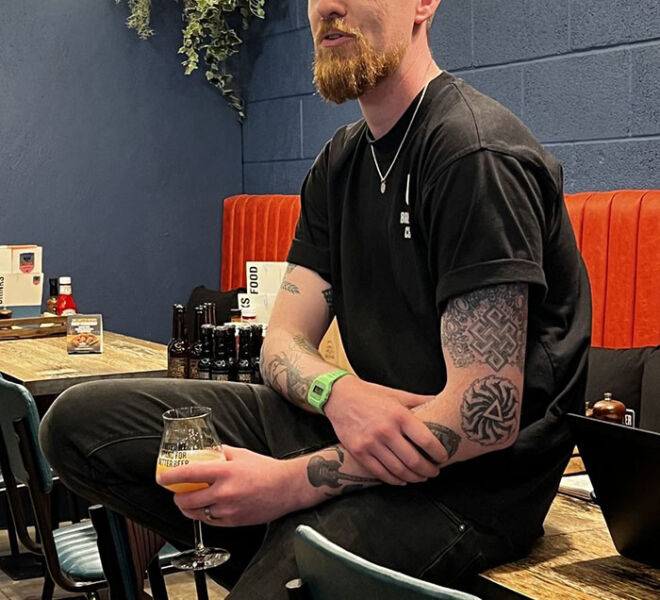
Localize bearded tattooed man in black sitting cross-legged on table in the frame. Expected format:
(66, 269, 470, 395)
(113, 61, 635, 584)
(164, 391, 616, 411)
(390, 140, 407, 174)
(41, 0, 591, 600)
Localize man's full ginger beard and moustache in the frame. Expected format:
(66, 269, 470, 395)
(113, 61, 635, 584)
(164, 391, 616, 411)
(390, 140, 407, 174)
(314, 19, 403, 104)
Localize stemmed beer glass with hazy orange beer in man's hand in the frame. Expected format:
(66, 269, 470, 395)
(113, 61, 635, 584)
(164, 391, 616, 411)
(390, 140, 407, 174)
(156, 406, 229, 571)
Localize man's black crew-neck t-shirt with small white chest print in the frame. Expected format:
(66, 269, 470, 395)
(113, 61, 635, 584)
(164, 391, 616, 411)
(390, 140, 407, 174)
(288, 72, 591, 544)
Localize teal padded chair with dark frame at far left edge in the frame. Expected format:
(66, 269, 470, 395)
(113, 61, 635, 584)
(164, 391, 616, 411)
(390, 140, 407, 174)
(0, 377, 177, 600)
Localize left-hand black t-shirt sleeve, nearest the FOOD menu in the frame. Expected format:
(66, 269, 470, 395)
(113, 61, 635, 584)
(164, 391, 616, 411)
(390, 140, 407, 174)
(287, 145, 331, 283)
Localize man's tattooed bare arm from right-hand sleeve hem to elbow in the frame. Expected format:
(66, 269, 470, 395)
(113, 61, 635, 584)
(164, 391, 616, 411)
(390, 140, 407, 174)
(413, 284, 528, 462)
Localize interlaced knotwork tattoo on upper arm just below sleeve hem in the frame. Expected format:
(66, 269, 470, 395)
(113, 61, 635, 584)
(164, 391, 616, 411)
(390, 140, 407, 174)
(441, 284, 527, 372)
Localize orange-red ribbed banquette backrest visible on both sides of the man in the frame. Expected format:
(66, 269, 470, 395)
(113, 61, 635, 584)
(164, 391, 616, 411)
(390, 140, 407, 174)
(221, 190, 660, 348)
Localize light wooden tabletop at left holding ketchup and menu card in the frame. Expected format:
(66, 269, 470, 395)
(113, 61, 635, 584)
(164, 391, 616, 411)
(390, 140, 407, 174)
(0, 331, 167, 398)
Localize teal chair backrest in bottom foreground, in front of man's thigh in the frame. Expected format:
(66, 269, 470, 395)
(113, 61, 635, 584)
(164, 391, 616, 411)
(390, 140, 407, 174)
(294, 525, 479, 600)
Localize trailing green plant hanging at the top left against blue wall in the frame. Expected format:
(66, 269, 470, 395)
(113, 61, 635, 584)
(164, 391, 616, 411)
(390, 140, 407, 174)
(115, 0, 266, 120)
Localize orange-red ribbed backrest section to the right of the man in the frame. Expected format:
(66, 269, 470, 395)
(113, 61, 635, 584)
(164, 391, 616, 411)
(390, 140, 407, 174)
(566, 190, 660, 348)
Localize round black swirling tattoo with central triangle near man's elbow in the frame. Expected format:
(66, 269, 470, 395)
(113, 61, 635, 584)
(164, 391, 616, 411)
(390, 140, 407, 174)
(461, 375, 519, 446)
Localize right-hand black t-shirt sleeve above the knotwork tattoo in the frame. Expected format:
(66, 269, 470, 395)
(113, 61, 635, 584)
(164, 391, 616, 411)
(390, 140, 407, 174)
(421, 149, 547, 310)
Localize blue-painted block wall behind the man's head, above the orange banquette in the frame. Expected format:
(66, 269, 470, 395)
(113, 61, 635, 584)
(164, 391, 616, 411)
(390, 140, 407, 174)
(243, 0, 660, 193)
